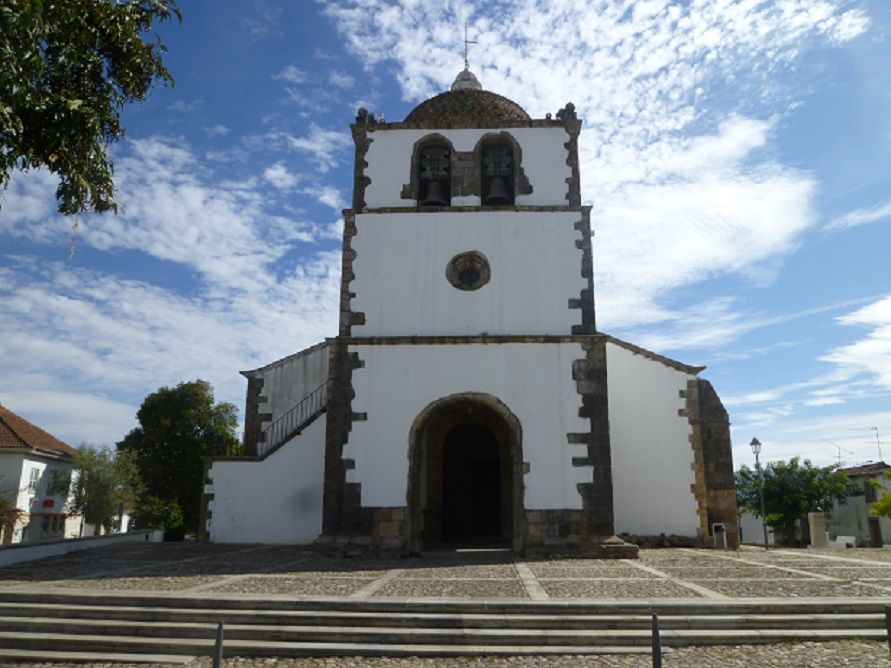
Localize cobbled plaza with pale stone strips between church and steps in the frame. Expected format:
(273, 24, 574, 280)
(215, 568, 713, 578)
(0, 542, 891, 600)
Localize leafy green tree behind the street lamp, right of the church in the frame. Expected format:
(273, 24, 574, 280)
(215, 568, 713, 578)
(736, 457, 851, 540)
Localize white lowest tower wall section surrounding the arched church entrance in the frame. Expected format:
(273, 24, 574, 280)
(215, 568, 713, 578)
(343, 343, 591, 509)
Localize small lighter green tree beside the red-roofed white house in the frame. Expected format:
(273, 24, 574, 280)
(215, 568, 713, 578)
(72, 443, 139, 531)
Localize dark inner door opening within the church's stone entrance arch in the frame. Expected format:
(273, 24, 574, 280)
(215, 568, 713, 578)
(442, 424, 504, 543)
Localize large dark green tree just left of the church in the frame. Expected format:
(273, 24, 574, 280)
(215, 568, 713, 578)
(118, 380, 239, 532)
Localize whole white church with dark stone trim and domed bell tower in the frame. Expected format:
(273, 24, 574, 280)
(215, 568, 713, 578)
(205, 70, 738, 556)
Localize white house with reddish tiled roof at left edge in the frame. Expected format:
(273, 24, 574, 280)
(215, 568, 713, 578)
(0, 406, 80, 544)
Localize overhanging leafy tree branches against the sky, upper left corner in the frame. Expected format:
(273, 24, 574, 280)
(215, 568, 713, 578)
(0, 0, 181, 214)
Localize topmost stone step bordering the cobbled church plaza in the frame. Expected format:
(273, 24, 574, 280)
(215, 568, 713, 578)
(0, 588, 891, 616)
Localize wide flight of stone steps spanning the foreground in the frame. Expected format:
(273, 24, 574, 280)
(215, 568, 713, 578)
(0, 590, 887, 663)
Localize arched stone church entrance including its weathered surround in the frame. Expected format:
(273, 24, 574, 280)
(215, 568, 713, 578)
(406, 393, 525, 553)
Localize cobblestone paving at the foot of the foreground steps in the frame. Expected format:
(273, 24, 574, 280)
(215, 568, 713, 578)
(1, 642, 891, 668)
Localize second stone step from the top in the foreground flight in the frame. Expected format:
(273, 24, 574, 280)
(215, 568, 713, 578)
(0, 603, 885, 630)
